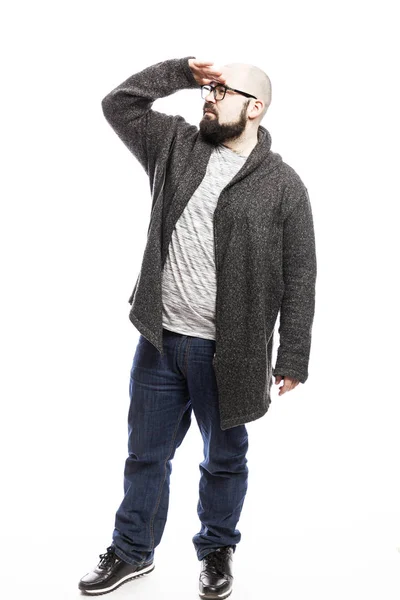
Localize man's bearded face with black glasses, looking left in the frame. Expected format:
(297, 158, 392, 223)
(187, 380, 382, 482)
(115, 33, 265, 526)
(199, 86, 250, 145)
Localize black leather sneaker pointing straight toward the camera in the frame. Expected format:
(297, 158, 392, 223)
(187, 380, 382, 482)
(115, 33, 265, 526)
(199, 546, 234, 600)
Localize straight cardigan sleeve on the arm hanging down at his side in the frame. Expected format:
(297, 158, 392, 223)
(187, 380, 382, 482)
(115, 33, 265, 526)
(272, 188, 317, 383)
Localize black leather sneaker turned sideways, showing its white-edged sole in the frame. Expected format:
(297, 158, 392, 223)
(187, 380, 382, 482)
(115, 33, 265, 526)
(78, 546, 154, 596)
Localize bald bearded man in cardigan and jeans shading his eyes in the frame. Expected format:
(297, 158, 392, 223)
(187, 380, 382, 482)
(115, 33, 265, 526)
(79, 57, 316, 598)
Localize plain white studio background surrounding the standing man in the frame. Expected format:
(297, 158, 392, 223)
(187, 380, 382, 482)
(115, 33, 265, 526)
(0, 0, 400, 600)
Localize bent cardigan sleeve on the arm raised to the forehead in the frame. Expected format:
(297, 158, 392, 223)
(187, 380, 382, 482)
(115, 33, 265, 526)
(101, 56, 200, 175)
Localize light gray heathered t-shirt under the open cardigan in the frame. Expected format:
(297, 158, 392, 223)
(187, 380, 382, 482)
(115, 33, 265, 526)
(162, 144, 247, 340)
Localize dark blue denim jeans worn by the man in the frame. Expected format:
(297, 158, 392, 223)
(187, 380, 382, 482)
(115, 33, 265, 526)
(112, 328, 248, 564)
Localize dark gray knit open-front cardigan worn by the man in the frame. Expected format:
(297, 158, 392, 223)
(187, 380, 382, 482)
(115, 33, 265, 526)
(102, 57, 317, 430)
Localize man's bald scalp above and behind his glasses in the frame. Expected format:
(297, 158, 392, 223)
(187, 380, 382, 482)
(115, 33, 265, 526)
(223, 63, 272, 121)
